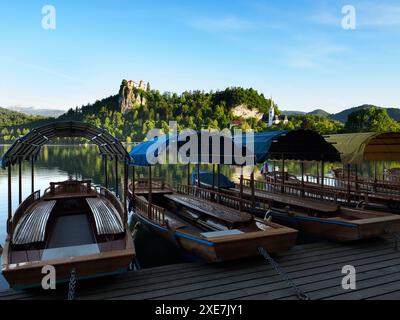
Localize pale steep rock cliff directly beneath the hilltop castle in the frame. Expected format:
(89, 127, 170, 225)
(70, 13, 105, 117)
(119, 80, 146, 113)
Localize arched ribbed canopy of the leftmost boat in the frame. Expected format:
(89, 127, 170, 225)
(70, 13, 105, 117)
(0, 121, 129, 169)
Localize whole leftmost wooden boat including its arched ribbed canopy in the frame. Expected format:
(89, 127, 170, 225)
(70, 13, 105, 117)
(1, 122, 135, 289)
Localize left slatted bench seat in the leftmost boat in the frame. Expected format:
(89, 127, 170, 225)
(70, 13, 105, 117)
(13, 200, 56, 245)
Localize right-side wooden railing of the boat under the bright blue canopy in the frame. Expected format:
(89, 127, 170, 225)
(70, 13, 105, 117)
(177, 184, 262, 211)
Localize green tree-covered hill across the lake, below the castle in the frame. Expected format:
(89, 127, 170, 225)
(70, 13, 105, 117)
(58, 84, 278, 141)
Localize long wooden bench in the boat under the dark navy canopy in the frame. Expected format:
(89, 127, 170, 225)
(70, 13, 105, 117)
(234, 188, 339, 213)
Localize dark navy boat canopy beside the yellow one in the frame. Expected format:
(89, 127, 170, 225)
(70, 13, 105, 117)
(235, 130, 340, 163)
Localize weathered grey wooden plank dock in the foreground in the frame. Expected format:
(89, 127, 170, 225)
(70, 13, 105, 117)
(0, 237, 400, 300)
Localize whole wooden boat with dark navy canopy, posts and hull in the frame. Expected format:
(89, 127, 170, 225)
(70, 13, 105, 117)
(217, 130, 400, 241)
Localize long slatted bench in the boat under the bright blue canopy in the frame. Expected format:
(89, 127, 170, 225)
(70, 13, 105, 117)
(165, 194, 253, 223)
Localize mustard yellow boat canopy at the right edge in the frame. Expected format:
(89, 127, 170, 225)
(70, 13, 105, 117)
(325, 132, 400, 164)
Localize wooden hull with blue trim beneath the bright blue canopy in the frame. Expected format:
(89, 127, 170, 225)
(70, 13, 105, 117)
(130, 181, 297, 262)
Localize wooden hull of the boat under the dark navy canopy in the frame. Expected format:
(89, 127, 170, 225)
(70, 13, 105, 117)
(194, 171, 400, 241)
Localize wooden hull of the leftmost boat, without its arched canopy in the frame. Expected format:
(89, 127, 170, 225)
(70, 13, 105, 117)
(2, 180, 135, 288)
